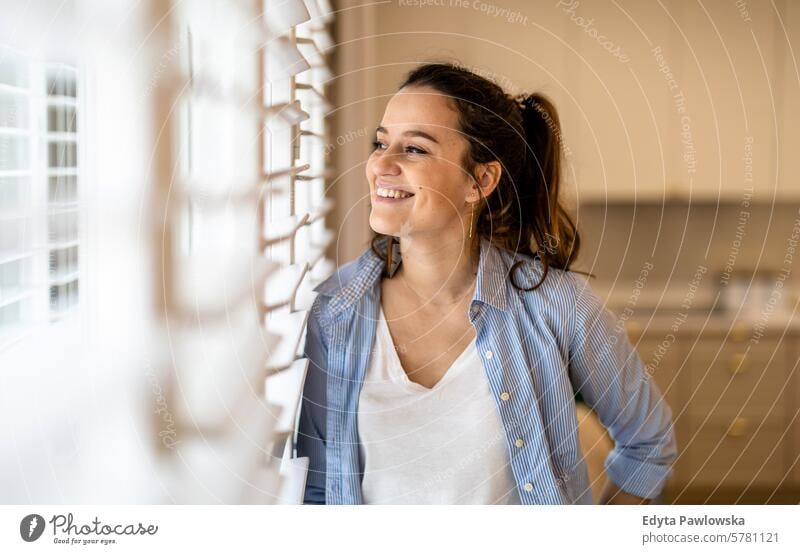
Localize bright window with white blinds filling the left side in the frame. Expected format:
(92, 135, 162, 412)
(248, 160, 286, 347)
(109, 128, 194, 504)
(0, 0, 333, 504)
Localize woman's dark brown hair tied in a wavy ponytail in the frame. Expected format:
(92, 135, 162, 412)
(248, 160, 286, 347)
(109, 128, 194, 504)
(370, 63, 594, 291)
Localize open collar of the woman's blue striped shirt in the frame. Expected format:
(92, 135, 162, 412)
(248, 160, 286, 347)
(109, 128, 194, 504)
(314, 237, 508, 317)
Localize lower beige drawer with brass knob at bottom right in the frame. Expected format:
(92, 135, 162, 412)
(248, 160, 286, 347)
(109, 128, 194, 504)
(676, 417, 789, 488)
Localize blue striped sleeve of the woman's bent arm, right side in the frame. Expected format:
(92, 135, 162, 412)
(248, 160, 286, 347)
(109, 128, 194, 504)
(569, 272, 678, 499)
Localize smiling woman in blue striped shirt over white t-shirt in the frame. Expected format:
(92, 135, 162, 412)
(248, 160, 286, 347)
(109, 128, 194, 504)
(297, 64, 677, 504)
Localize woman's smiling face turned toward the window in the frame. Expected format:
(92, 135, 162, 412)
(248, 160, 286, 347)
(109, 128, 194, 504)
(366, 87, 479, 238)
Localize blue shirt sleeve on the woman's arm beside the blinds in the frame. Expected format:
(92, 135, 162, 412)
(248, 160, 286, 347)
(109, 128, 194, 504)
(297, 295, 328, 504)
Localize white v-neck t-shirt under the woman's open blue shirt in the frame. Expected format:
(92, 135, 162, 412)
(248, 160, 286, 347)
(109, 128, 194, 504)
(357, 307, 520, 504)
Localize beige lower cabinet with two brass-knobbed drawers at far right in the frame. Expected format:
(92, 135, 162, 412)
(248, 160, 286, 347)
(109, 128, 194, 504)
(681, 336, 788, 488)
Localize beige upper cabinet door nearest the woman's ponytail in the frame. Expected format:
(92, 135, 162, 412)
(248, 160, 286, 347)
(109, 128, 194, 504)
(558, 0, 675, 202)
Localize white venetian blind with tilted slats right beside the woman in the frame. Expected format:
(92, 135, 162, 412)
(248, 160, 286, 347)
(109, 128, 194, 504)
(154, 0, 334, 503)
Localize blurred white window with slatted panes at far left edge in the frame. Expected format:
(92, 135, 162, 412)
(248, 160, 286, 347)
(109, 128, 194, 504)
(0, 47, 80, 348)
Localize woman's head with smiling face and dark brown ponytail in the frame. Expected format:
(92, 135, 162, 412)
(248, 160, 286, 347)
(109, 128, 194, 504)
(366, 64, 580, 288)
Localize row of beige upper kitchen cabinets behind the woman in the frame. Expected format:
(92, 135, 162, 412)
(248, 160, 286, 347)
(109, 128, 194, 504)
(565, 0, 800, 203)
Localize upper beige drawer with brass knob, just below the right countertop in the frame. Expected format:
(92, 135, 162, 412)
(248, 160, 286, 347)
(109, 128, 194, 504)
(687, 338, 789, 421)
